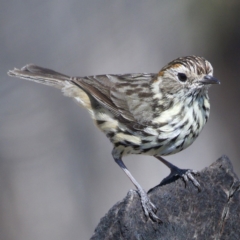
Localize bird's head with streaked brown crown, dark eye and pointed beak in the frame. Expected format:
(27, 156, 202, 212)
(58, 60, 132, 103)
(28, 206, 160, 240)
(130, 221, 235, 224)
(156, 56, 220, 95)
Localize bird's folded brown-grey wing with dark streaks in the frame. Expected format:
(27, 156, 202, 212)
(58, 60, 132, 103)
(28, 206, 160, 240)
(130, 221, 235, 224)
(72, 73, 156, 125)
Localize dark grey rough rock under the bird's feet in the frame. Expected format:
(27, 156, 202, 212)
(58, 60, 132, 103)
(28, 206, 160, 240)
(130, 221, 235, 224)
(91, 156, 240, 240)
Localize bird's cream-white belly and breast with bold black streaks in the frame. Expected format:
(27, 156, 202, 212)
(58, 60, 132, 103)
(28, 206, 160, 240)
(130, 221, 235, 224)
(95, 98, 208, 156)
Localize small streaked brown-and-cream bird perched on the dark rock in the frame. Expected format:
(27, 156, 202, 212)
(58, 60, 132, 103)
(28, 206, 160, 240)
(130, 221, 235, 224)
(8, 56, 220, 222)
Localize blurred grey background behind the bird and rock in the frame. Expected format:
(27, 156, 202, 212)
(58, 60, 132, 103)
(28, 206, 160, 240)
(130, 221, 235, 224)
(0, 0, 240, 240)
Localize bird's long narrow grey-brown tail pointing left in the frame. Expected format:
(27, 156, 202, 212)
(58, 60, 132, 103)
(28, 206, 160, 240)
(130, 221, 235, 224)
(8, 64, 71, 89)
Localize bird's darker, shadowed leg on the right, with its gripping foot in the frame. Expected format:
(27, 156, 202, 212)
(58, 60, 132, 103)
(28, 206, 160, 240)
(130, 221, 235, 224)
(155, 156, 201, 190)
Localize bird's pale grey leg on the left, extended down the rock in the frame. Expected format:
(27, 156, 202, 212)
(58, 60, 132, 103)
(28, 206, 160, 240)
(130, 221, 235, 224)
(114, 157, 161, 222)
